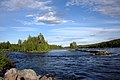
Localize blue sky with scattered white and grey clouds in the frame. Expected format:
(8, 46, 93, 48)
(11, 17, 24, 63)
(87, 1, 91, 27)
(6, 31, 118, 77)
(0, 0, 120, 46)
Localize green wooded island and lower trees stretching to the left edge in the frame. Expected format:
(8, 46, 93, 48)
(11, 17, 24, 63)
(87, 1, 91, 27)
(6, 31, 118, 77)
(0, 33, 62, 53)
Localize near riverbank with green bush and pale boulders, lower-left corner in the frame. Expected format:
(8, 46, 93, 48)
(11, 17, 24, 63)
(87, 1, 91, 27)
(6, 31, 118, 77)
(0, 53, 57, 80)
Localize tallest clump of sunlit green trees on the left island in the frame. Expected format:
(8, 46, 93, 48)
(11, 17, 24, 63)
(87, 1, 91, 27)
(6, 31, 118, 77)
(20, 33, 50, 52)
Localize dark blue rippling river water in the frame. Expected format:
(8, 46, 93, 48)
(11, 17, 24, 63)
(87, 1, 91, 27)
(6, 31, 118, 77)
(8, 48, 120, 80)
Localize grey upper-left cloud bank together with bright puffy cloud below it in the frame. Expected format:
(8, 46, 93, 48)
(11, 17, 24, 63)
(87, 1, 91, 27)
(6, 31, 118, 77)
(2, 0, 73, 25)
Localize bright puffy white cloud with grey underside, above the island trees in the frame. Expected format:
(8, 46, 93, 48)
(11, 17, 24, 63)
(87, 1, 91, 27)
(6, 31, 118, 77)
(22, 10, 74, 25)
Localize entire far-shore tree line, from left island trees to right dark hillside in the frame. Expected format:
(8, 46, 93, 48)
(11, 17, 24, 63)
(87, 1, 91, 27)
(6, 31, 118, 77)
(0, 33, 120, 52)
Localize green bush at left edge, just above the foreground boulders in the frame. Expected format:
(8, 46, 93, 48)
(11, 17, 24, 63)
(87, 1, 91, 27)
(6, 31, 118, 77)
(0, 54, 12, 71)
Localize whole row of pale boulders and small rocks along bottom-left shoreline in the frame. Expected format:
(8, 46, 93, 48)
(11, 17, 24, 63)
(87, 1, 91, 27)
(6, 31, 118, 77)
(0, 68, 58, 80)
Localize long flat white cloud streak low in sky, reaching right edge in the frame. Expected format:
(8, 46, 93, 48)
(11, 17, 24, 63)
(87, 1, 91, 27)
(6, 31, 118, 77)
(51, 27, 120, 37)
